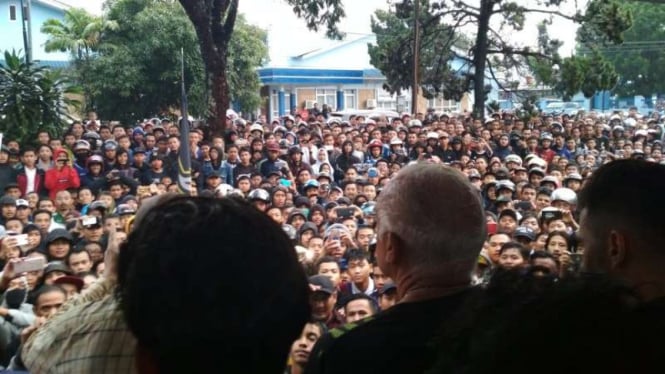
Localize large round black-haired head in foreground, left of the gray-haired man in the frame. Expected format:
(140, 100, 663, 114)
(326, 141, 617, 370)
(118, 197, 310, 373)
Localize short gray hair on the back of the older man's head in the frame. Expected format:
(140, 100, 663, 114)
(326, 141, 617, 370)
(375, 163, 487, 271)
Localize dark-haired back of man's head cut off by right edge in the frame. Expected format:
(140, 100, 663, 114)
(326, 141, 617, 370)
(578, 160, 665, 274)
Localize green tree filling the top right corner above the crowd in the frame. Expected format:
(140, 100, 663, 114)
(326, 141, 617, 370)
(578, 2, 665, 98)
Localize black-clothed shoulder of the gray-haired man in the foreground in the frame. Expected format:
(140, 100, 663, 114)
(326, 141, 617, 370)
(306, 287, 478, 374)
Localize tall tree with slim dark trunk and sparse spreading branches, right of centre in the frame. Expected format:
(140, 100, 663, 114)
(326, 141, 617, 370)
(368, 0, 631, 117)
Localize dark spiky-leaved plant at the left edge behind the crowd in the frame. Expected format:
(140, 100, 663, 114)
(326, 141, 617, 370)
(0, 51, 80, 144)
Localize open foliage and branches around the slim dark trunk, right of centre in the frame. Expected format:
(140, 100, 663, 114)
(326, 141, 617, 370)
(370, 0, 632, 117)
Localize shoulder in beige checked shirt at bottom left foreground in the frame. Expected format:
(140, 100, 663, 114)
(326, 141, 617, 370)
(21, 280, 136, 373)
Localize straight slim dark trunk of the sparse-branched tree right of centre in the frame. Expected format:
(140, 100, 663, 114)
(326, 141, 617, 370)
(473, 0, 494, 119)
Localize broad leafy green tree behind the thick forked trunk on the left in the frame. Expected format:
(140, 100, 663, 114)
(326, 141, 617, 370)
(67, 0, 268, 123)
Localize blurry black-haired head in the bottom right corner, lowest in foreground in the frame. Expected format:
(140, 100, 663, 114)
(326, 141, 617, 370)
(427, 271, 665, 374)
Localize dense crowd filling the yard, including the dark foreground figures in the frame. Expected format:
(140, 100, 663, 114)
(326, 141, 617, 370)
(0, 108, 665, 374)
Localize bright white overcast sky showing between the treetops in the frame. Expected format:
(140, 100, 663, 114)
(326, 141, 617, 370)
(60, 0, 587, 55)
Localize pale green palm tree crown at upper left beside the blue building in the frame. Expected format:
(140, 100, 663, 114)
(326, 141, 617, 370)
(41, 8, 118, 62)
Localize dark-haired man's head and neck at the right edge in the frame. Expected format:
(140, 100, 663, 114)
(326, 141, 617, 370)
(578, 160, 665, 299)
